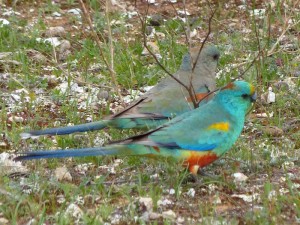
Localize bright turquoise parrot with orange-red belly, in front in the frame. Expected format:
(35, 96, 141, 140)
(15, 81, 256, 174)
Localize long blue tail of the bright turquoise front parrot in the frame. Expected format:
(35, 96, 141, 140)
(14, 145, 127, 161)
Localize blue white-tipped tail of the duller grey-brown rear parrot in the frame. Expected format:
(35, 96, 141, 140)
(20, 120, 109, 139)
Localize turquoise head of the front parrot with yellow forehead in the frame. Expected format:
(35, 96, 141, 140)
(216, 81, 256, 115)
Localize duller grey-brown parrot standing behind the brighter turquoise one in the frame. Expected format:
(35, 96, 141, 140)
(21, 46, 220, 138)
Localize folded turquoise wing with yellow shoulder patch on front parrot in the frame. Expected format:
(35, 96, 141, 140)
(119, 104, 232, 151)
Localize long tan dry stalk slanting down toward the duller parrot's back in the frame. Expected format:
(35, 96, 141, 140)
(79, 0, 122, 99)
